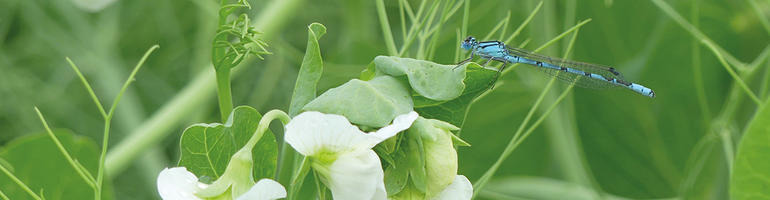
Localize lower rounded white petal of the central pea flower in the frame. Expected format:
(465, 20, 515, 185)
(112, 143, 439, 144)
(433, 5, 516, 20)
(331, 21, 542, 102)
(327, 150, 387, 200)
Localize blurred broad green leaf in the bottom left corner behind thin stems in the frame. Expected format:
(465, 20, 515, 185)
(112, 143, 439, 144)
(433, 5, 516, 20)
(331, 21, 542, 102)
(0, 130, 110, 200)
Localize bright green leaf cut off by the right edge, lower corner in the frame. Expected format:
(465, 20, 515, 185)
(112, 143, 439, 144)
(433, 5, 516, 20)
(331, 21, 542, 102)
(730, 101, 770, 200)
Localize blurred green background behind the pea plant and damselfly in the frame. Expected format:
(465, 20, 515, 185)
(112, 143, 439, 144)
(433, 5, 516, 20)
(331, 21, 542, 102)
(0, 0, 770, 199)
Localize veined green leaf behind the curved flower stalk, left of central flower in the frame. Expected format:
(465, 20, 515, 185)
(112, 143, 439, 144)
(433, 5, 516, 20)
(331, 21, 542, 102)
(179, 106, 278, 181)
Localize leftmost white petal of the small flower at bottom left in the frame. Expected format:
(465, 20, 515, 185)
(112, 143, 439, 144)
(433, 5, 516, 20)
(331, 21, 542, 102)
(158, 167, 200, 200)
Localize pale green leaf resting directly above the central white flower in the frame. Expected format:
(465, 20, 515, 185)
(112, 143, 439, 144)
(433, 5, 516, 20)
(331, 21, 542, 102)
(303, 76, 413, 127)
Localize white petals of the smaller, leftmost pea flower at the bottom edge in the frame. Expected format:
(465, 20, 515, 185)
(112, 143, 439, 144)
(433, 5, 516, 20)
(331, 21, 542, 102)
(157, 167, 286, 200)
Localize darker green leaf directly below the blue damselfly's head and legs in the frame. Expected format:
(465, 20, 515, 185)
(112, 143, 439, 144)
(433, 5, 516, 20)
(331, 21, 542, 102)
(413, 63, 497, 127)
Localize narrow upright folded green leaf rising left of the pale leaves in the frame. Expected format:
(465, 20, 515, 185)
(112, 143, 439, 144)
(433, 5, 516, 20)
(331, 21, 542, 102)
(289, 23, 326, 116)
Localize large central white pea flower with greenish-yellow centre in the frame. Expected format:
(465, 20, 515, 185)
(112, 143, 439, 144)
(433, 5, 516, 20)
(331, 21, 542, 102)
(285, 111, 418, 200)
